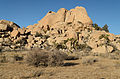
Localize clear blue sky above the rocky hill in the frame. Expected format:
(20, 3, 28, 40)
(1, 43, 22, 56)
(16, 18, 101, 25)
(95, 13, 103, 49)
(0, 0, 120, 34)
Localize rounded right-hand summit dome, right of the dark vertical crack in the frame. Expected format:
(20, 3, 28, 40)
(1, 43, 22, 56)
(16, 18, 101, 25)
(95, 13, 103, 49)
(65, 7, 93, 24)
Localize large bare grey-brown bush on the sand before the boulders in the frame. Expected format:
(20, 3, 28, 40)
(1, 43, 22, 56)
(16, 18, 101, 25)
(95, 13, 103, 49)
(25, 49, 65, 66)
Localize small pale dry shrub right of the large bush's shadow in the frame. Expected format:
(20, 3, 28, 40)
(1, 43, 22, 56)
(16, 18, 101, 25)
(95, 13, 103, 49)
(82, 57, 98, 65)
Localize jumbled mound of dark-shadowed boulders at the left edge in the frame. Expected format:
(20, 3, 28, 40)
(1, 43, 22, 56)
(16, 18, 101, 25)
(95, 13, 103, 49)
(0, 20, 25, 51)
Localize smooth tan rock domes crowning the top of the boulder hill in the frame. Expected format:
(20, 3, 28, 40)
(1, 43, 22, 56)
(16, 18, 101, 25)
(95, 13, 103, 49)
(27, 7, 93, 26)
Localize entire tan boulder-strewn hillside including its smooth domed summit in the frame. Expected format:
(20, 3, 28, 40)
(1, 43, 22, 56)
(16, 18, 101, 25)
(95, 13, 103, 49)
(0, 7, 120, 53)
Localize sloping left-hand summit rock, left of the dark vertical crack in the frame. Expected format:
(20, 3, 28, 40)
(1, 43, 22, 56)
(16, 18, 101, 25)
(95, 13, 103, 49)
(38, 8, 67, 26)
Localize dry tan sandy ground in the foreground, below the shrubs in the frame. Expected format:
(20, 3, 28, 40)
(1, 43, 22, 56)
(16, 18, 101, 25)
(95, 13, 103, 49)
(0, 57, 120, 79)
